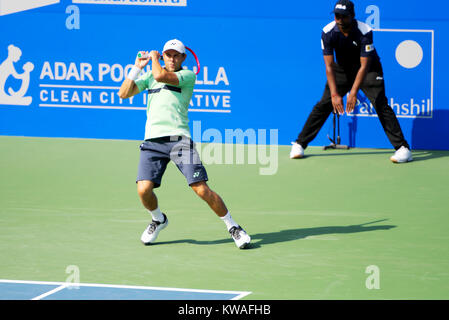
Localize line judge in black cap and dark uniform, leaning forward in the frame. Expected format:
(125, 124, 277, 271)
(290, 0, 413, 163)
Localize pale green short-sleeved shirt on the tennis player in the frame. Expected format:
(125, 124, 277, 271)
(135, 69, 196, 140)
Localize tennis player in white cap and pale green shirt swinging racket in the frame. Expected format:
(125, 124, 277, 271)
(118, 39, 251, 249)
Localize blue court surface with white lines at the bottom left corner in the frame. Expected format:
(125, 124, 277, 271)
(0, 280, 250, 300)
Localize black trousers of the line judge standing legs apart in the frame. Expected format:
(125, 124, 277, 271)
(296, 66, 410, 150)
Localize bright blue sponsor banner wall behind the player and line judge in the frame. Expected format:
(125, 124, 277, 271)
(0, 0, 449, 150)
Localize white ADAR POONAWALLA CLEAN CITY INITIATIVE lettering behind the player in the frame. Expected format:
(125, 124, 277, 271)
(34, 61, 231, 113)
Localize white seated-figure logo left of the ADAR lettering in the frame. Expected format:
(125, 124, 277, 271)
(0, 44, 34, 106)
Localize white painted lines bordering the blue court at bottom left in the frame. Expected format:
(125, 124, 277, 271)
(0, 279, 252, 300)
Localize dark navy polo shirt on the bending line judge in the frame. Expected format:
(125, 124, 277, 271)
(321, 19, 382, 74)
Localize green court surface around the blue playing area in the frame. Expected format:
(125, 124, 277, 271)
(0, 136, 449, 300)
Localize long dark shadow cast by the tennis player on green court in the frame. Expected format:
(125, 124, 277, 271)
(152, 219, 397, 249)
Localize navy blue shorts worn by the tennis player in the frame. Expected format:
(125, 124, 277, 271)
(136, 136, 208, 188)
